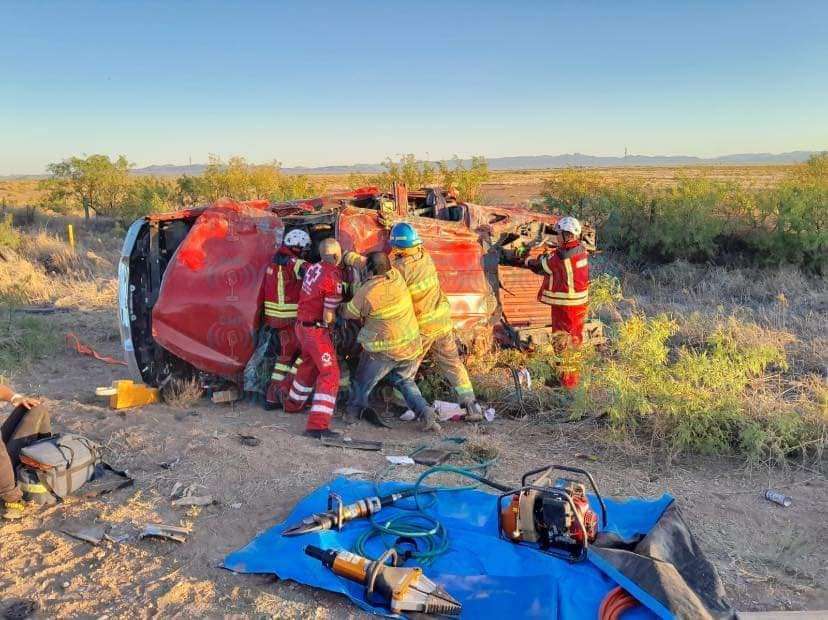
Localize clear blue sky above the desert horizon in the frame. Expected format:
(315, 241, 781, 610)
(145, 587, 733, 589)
(0, 0, 828, 174)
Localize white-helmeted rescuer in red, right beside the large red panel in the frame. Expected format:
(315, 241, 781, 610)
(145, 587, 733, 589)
(264, 228, 310, 410)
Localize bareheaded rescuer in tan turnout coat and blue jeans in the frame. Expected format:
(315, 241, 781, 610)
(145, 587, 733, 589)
(342, 252, 440, 431)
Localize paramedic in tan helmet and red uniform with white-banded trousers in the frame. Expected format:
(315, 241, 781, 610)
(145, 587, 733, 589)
(285, 239, 342, 439)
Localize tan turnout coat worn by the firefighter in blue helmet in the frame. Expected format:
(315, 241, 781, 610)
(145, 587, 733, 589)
(391, 248, 452, 338)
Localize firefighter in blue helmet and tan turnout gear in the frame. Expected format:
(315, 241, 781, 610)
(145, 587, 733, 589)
(344, 222, 483, 421)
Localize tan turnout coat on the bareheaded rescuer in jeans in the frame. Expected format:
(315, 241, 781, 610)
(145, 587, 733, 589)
(343, 268, 421, 360)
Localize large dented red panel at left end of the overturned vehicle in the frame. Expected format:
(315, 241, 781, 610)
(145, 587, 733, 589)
(152, 199, 282, 378)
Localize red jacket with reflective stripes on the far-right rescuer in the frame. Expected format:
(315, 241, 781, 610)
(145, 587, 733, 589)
(534, 241, 589, 306)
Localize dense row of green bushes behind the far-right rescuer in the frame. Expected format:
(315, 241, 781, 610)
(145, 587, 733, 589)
(542, 154, 828, 273)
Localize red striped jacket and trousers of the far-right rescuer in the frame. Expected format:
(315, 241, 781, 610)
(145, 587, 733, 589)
(526, 240, 589, 389)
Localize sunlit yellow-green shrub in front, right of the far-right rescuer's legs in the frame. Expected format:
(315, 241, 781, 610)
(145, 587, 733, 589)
(573, 315, 828, 462)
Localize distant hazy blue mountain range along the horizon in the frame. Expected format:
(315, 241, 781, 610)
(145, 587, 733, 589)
(133, 151, 820, 176)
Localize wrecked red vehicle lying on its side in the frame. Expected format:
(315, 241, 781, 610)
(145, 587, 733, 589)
(119, 188, 588, 385)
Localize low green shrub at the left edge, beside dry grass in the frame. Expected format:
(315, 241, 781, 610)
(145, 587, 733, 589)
(0, 308, 60, 378)
